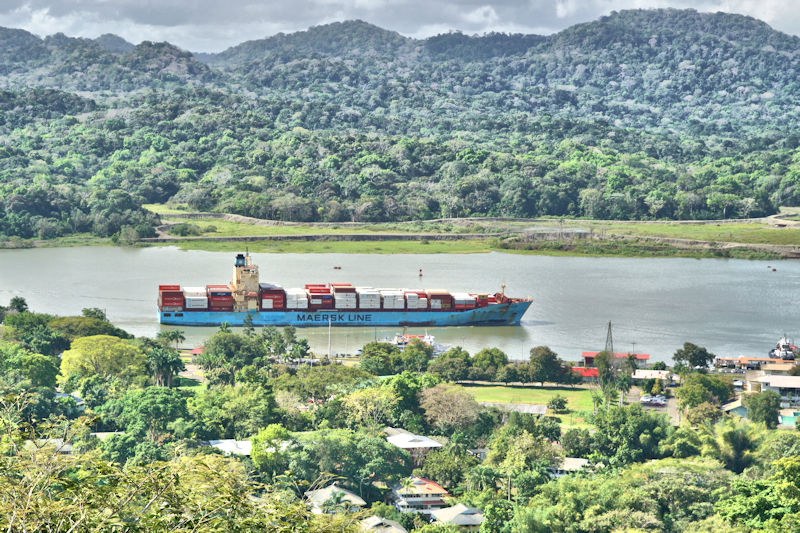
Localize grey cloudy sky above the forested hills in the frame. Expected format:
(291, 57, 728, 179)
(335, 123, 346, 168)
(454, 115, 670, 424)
(0, 0, 800, 52)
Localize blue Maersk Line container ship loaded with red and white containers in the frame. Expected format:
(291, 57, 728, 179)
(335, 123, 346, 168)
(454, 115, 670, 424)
(158, 254, 531, 327)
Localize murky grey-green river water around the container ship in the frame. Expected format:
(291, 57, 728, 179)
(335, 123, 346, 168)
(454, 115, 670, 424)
(0, 247, 800, 361)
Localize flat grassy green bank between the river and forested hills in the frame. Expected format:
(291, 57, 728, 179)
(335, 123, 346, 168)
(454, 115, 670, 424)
(0, 204, 800, 260)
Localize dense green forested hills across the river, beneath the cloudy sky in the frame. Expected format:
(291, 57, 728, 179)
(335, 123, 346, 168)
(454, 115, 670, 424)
(0, 10, 800, 238)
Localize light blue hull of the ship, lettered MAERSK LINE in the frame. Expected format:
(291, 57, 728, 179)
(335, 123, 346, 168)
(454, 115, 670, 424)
(159, 301, 531, 327)
